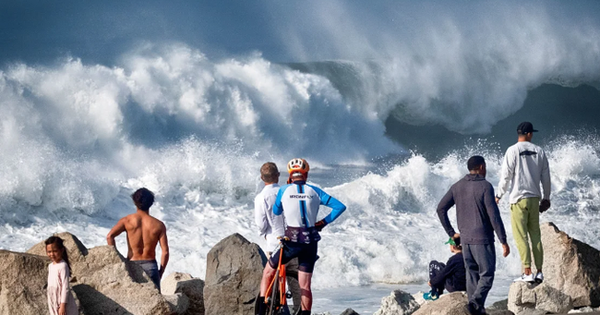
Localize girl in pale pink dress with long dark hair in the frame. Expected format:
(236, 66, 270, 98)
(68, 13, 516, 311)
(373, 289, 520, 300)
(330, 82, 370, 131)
(45, 236, 79, 315)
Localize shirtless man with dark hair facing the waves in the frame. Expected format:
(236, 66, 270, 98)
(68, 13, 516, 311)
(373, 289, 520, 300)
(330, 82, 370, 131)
(106, 188, 169, 291)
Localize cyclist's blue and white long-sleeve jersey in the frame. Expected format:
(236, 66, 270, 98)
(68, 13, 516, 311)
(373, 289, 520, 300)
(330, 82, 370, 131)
(273, 181, 346, 228)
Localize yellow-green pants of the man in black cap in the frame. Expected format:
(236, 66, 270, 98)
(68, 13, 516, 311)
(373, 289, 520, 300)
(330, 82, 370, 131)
(510, 198, 544, 270)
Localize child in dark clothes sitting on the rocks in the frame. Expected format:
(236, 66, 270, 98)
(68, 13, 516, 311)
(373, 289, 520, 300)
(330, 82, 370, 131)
(423, 237, 467, 300)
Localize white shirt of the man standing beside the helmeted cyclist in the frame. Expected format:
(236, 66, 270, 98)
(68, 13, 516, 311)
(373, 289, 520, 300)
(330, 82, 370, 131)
(254, 184, 285, 252)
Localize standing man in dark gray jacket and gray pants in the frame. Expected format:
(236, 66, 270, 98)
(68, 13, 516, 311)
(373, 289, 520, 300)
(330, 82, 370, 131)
(437, 156, 510, 315)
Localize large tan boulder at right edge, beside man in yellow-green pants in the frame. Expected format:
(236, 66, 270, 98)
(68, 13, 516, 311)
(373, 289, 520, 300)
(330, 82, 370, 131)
(540, 223, 600, 307)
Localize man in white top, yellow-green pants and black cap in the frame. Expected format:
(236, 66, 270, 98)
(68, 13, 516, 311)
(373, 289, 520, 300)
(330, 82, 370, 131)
(496, 122, 550, 283)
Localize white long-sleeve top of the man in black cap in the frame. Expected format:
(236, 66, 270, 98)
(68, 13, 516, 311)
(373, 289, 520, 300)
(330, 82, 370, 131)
(496, 141, 550, 204)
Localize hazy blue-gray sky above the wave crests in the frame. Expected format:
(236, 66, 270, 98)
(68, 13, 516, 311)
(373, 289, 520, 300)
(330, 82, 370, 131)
(0, 0, 600, 64)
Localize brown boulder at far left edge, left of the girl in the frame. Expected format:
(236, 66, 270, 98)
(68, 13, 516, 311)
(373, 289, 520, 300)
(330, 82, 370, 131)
(0, 250, 56, 315)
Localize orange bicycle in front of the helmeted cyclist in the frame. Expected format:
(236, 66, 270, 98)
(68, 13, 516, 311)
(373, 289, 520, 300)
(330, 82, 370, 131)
(258, 237, 292, 315)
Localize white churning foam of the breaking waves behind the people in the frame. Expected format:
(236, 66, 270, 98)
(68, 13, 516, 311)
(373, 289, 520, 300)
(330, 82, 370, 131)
(0, 45, 600, 288)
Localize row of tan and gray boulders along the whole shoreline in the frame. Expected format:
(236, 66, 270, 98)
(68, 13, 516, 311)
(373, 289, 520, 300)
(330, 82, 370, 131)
(0, 223, 600, 315)
